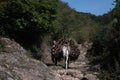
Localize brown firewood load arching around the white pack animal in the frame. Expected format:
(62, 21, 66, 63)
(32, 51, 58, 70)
(51, 39, 80, 61)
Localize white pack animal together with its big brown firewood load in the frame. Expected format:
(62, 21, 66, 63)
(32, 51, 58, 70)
(51, 39, 80, 69)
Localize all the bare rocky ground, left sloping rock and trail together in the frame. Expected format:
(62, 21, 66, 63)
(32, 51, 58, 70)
(0, 38, 99, 80)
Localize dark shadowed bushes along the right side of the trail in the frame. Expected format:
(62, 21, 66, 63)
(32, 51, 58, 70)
(88, 2, 120, 80)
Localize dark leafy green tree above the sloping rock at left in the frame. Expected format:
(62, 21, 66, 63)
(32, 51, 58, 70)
(0, 0, 57, 48)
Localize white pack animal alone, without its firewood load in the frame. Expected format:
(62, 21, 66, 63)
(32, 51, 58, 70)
(62, 44, 70, 69)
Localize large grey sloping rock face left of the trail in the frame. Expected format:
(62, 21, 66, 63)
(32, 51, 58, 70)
(0, 38, 55, 80)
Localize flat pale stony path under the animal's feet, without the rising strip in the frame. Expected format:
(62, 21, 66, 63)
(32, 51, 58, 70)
(48, 58, 99, 80)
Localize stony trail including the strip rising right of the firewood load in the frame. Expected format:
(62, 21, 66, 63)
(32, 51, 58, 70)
(48, 42, 99, 80)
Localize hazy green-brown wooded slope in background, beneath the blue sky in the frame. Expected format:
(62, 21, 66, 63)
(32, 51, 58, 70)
(54, 2, 100, 43)
